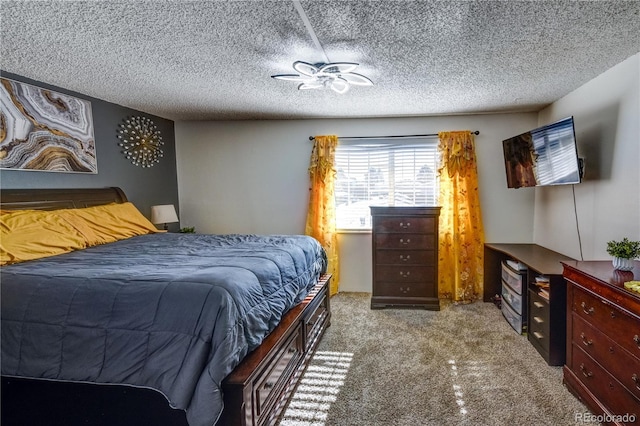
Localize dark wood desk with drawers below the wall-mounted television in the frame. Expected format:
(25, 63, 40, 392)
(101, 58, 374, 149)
(483, 243, 574, 365)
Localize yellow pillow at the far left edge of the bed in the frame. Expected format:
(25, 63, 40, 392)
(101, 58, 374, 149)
(0, 210, 87, 265)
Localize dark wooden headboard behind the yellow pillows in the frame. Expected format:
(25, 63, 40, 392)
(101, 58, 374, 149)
(0, 187, 127, 210)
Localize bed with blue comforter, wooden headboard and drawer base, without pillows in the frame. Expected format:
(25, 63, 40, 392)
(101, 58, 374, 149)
(1, 188, 330, 426)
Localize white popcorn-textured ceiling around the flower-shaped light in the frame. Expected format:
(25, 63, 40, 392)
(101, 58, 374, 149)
(0, 0, 640, 120)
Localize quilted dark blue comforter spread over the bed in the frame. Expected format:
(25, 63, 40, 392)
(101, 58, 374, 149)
(1, 234, 326, 426)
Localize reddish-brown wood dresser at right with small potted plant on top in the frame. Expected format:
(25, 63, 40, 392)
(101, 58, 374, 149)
(563, 261, 640, 424)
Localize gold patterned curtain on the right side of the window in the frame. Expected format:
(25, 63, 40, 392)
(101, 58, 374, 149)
(438, 130, 484, 303)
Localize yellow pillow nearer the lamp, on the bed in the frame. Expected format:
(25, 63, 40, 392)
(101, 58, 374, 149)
(58, 203, 160, 246)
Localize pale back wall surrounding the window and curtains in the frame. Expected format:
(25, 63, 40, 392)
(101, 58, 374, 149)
(175, 113, 537, 292)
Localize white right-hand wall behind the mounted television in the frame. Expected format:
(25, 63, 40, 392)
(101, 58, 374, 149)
(534, 54, 640, 260)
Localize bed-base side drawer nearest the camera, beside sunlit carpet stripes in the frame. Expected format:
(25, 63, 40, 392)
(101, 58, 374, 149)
(253, 325, 302, 421)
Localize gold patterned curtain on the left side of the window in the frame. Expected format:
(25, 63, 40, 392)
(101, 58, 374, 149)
(305, 135, 340, 295)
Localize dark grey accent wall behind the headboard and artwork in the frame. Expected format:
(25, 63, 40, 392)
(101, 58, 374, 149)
(0, 71, 180, 231)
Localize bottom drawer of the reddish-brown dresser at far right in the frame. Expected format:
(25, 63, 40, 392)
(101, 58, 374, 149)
(571, 342, 640, 419)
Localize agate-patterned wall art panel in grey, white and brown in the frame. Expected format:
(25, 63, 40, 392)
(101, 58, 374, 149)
(0, 78, 98, 174)
